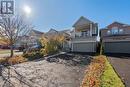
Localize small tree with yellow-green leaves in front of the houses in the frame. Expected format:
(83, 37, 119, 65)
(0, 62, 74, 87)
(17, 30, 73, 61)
(40, 35, 65, 55)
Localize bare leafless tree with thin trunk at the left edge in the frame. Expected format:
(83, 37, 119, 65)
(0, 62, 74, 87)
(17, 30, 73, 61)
(0, 15, 32, 57)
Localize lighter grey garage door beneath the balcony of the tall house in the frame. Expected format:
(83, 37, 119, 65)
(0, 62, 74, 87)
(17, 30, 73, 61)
(73, 42, 96, 52)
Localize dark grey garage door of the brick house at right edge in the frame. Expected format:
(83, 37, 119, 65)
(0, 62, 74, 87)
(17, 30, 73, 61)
(104, 42, 130, 53)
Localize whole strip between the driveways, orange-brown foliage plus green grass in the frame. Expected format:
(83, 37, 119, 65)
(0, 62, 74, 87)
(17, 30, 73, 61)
(80, 55, 125, 87)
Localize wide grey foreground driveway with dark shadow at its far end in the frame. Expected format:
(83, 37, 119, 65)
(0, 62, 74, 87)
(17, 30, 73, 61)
(0, 54, 91, 87)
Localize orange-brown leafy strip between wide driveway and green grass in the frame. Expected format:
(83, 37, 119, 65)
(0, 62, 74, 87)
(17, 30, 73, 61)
(81, 56, 106, 87)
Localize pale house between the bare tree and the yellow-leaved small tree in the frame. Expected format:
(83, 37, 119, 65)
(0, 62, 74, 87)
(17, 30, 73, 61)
(15, 29, 44, 47)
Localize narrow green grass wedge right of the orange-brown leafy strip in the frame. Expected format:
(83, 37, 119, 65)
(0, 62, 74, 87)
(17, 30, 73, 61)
(101, 59, 125, 87)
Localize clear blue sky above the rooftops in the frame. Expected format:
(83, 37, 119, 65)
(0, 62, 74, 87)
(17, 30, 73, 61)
(15, 0, 130, 32)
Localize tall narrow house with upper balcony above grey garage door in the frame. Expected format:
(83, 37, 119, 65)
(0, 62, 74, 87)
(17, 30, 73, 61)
(70, 16, 98, 53)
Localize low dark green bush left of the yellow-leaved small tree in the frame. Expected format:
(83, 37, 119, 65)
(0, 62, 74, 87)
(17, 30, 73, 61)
(23, 52, 44, 60)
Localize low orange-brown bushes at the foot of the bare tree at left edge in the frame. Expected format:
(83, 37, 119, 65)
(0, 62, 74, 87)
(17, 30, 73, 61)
(0, 56, 27, 65)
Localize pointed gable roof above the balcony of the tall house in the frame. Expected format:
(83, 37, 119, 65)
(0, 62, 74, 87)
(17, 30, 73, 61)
(73, 16, 93, 27)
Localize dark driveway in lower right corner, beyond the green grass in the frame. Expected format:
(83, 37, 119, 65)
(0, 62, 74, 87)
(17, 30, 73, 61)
(108, 57, 130, 87)
